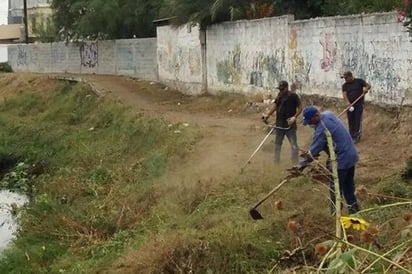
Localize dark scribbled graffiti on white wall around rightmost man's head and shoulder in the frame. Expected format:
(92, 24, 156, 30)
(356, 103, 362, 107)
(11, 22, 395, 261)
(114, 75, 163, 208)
(341, 42, 401, 101)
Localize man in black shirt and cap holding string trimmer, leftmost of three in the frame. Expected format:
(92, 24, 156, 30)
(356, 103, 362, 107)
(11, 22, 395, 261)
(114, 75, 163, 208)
(262, 81, 302, 164)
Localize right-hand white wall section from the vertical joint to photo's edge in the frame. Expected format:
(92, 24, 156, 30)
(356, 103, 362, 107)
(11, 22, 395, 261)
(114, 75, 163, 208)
(289, 13, 412, 104)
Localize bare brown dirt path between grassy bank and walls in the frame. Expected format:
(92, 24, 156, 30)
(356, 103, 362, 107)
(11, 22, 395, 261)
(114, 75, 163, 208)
(84, 76, 296, 183)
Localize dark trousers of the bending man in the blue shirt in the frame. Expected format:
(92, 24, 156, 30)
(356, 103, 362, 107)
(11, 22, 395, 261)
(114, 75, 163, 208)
(329, 166, 359, 214)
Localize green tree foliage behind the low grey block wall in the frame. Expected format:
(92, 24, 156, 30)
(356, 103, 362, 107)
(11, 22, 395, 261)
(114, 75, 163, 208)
(52, 0, 163, 40)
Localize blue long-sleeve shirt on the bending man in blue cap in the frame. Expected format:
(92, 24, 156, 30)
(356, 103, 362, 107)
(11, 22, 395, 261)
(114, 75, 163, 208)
(306, 111, 359, 169)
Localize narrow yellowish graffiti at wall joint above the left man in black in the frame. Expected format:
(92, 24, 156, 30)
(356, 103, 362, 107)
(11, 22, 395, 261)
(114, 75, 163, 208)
(289, 30, 312, 86)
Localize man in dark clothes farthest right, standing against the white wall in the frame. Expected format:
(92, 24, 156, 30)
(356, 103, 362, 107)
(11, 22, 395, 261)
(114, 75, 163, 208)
(341, 71, 371, 143)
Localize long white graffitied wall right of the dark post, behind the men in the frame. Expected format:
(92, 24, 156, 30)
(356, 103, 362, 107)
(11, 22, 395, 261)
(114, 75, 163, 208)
(206, 12, 412, 104)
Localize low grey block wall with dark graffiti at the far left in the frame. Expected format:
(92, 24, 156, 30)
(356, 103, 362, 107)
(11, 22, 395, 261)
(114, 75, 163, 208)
(8, 38, 158, 80)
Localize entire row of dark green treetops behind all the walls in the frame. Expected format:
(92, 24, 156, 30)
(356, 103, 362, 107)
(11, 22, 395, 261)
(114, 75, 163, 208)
(48, 0, 411, 40)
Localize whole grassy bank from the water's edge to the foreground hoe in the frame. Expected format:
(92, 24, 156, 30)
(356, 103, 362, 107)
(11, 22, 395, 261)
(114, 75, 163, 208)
(0, 84, 286, 273)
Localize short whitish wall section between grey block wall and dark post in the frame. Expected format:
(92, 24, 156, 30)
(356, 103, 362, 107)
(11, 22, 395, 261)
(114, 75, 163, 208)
(157, 26, 206, 95)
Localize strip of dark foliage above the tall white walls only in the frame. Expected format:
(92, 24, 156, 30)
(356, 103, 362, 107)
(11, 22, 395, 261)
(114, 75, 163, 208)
(161, 0, 402, 27)
